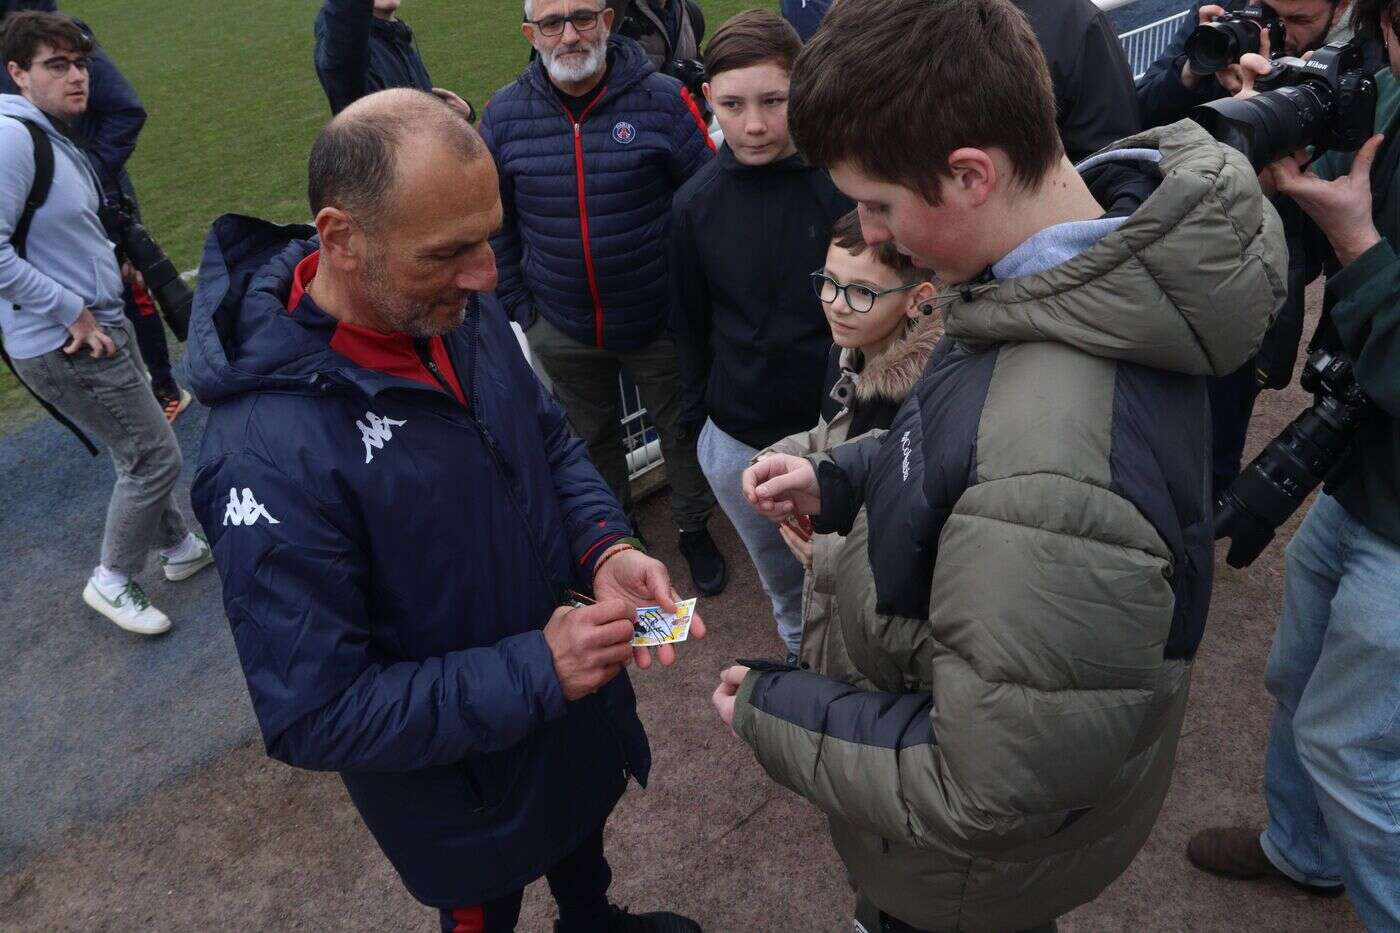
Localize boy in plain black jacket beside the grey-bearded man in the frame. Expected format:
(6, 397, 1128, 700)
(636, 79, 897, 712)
(671, 10, 853, 653)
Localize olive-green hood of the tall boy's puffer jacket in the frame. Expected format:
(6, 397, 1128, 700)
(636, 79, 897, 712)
(945, 120, 1288, 375)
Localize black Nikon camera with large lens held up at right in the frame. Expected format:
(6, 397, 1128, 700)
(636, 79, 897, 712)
(1191, 41, 1376, 170)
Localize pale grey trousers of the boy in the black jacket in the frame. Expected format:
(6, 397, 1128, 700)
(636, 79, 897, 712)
(696, 419, 804, 654)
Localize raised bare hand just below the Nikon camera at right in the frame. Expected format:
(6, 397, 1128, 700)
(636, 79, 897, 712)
(1260, 134, 1385, 266)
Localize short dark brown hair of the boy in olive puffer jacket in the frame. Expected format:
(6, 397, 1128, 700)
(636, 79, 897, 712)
(788, 0, 1064, 205)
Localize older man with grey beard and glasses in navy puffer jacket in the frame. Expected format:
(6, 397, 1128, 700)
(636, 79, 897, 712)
(482, 0, 727, 595)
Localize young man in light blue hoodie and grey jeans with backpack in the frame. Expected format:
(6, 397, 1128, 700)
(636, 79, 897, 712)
(0, 11, 211, 635)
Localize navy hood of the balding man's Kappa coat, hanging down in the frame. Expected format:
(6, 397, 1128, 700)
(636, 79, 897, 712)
(183, 214, 350, 405)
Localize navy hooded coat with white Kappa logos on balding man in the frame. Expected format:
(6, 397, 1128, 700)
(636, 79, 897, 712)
(186, 216, 650, 908)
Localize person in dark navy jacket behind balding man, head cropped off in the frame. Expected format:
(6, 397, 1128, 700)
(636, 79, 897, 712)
(314, 0, 476, 123)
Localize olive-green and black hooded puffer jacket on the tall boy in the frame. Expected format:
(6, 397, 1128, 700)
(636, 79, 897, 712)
(734, 120, 1288, 932)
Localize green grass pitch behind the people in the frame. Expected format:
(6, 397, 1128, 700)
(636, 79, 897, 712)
(0, 0, 777, 433)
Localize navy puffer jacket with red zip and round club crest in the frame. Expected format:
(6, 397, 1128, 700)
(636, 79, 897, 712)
(482, 35, 714, 350)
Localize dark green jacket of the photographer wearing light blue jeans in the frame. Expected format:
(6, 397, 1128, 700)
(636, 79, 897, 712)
(1317, 69, 1400, 545)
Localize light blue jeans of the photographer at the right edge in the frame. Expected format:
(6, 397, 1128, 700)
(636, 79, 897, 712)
(1260, 495, 1400, 930)
